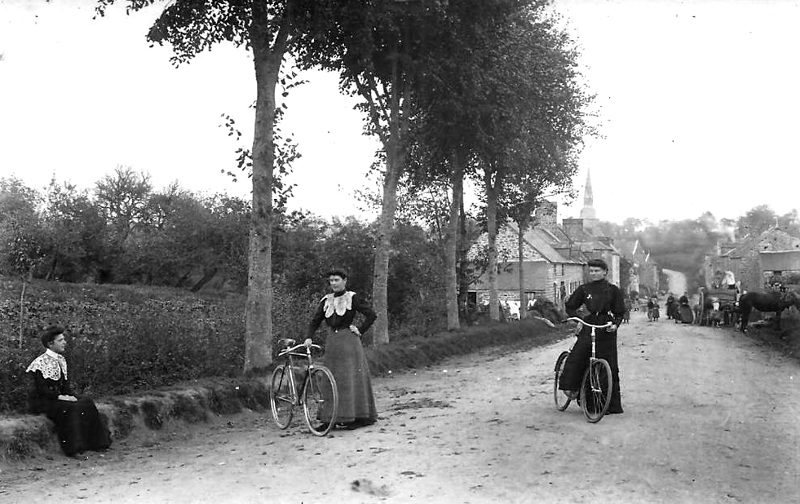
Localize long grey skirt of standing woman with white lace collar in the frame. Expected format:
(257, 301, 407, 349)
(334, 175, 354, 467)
(325, 329, 378, 425)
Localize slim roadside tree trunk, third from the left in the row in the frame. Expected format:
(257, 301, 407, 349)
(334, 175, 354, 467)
(445, 150, 464, 330)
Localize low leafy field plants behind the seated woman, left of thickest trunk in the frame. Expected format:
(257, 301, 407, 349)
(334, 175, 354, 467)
(0, 280, 244, 411)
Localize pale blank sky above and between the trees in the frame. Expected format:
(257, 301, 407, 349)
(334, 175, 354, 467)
(0, 0, 800, 222)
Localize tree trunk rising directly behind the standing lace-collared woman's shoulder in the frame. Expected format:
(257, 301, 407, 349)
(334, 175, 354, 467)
(372, 138, 404, 345)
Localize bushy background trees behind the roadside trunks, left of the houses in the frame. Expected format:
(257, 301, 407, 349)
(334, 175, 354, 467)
(0, 167, 456, 334)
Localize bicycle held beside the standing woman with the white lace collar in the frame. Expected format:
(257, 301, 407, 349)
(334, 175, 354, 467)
(269, 338, 339, 436)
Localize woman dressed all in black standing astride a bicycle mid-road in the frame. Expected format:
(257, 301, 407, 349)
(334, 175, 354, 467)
(558, 259, 625, 414)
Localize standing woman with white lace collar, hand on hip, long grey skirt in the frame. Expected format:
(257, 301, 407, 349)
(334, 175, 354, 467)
(306, 269, 378, 429)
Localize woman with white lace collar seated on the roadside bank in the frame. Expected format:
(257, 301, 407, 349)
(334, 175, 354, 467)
(26, 326, 111, 457)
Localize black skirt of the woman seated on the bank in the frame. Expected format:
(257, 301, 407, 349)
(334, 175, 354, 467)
(44, 398, 111, 456)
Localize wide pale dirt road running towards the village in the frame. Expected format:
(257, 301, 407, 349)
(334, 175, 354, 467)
(0, 312, 800, 504)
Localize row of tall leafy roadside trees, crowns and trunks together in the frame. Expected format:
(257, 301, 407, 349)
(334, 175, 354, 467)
(81, 0, 591, 370)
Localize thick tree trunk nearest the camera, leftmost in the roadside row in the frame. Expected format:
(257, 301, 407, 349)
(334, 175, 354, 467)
(244, 34, 283, 372)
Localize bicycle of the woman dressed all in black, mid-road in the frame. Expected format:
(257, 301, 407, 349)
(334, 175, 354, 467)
(553, 317, 613, 423)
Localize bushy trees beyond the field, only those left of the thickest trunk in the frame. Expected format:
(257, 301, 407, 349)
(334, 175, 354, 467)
(0, 167, 250, 290)
